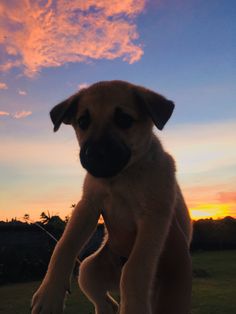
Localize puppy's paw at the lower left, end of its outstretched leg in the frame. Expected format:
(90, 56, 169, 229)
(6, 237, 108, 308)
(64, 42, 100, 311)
(31, 283, 66, 314)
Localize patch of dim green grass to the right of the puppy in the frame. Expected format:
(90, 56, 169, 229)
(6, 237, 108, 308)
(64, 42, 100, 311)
(192, 251, 236, 314)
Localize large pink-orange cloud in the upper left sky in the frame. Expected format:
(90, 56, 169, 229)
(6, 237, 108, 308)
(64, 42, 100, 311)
(0, 0, 147, 76)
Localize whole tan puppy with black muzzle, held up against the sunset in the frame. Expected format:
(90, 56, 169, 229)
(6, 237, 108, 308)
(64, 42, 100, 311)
(32, 81, 191, 314)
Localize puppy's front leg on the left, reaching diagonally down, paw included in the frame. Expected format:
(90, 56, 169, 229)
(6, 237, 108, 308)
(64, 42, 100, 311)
(32, 199, 100, 314)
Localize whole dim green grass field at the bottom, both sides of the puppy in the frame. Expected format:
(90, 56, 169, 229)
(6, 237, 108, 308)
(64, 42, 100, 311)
(0, 251, 236, 314)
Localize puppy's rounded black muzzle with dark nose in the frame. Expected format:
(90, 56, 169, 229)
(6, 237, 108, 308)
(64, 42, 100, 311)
(80, 137, 131, 178)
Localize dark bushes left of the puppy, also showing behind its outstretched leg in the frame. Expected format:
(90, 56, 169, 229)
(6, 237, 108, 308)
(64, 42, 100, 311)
(0, 216, 104, 284)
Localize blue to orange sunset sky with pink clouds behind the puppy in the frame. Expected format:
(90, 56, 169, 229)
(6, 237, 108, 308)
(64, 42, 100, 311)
(0, 0, 236, 220)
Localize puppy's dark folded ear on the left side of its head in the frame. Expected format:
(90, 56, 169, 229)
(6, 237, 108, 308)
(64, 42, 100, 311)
(50, 93, 79, 132)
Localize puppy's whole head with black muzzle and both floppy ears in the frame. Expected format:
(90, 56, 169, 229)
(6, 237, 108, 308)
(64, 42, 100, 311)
(51, 81, 173, 178)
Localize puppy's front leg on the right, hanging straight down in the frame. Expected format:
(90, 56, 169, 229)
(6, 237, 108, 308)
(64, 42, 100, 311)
(120, 201, 173, 314)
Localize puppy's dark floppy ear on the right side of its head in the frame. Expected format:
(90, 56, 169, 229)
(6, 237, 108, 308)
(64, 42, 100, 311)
(135, 86, 175, 130)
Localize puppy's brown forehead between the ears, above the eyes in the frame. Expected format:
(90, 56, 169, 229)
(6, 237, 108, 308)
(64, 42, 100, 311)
(79, 82, 136, 112)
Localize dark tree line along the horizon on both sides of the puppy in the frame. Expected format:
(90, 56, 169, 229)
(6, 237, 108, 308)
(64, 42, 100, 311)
(0, 212, 236, 284)
